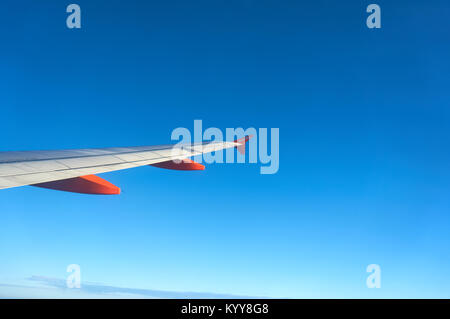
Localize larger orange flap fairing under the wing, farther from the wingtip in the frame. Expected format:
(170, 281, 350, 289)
(31, 175, 120, 195)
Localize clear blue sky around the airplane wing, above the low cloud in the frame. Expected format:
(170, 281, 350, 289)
(0, 0, 450, 298)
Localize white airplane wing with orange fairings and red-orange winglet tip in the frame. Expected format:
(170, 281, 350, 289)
(0, 136, 250, 195)
